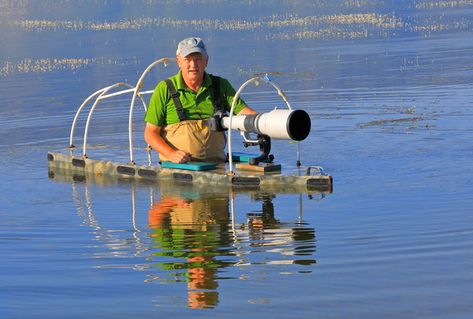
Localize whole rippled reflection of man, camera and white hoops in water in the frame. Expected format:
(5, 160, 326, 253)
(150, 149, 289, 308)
(68, 182, 316, 308)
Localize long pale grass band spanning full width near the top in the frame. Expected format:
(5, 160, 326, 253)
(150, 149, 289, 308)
(0, 12, 471, 40)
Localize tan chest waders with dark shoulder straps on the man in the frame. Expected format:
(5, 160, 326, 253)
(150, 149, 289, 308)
(159, 76, 227, 163)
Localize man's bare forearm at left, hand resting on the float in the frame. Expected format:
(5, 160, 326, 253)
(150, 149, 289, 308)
(144, 123, 191, 163)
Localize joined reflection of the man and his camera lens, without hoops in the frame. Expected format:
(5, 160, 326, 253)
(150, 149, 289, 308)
(149, 189, 316, 308)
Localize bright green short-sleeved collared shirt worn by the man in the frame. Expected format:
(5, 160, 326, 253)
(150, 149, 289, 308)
(145, 71, 246, 126)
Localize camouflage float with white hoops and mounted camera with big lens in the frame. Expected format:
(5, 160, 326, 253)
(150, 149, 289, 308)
(48, 58, 333, 193)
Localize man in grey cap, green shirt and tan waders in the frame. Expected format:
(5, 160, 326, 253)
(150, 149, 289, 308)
(144, 37, 256, 163)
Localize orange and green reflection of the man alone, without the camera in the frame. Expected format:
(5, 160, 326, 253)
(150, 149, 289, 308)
(149, 194, 229, 308)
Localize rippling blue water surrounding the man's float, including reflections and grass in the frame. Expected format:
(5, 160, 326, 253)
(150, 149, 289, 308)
(0, 0, 473, 318)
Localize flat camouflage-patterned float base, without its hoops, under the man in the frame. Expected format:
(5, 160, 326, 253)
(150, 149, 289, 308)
(48, 152, 333, 193)
